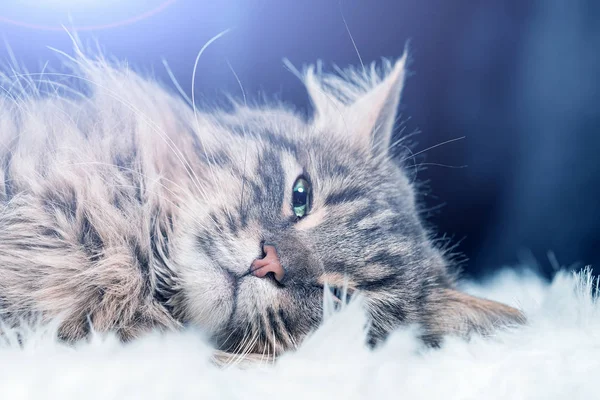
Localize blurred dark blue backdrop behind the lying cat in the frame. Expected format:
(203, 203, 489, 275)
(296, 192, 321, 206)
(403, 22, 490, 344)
(0, 0, 600, 275)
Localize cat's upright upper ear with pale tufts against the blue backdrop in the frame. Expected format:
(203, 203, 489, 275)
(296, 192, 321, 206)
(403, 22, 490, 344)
(305, 52, 407, 155)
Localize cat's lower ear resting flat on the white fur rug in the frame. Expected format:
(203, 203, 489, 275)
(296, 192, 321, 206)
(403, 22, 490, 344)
(428, 289, 525, 337)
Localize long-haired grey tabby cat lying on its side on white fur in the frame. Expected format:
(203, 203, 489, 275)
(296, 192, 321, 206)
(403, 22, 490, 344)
(0, 47, 525, 354)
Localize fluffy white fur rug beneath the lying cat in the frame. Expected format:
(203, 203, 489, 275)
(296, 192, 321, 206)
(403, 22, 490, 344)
(0, 271, 600, 400)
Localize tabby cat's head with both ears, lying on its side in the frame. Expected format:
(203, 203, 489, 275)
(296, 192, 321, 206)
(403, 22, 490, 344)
(165, 51, 522, 353)
